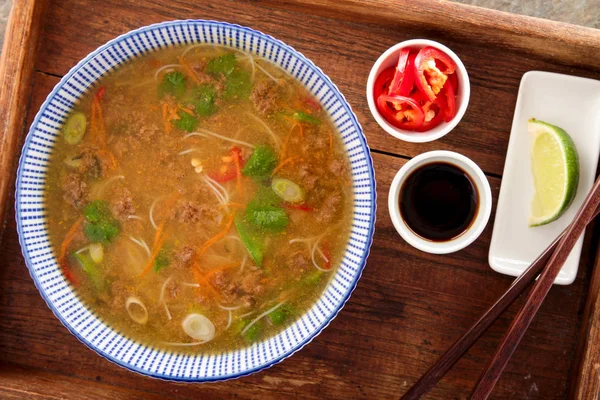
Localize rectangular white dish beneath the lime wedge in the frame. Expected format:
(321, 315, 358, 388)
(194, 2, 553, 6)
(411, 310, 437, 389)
(489, 71, 600, 285)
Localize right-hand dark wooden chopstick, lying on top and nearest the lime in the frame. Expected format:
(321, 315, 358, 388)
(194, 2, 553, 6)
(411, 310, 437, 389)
(471, 178, 600, 400)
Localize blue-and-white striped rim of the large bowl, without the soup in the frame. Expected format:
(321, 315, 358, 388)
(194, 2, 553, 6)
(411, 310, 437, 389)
(15, 20, 376, 382)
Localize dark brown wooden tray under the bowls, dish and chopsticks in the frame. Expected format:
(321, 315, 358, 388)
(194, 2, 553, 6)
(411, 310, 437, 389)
(0, 0, 600, 400)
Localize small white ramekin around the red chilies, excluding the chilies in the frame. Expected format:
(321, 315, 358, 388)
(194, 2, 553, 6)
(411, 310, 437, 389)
(367, 39, 471, 143)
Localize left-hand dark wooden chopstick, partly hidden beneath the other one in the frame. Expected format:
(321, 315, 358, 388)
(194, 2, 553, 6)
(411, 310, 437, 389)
(401, 185, 600, 400)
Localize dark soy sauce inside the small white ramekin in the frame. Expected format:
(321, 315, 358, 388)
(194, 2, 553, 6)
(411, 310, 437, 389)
(399, 162, 479, 242)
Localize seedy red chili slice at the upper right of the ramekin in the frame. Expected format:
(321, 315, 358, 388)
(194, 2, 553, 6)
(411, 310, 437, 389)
(415, 47, 456, 101)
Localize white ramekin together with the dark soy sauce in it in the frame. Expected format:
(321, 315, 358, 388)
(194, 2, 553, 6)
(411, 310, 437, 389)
(388, 151, 492, 254)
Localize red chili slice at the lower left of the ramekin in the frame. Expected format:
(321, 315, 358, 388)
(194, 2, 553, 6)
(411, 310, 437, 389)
(377, 94, 425, 130)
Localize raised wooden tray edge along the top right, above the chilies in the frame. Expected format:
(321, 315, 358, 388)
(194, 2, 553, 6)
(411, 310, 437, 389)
(264, 0, 600, 68)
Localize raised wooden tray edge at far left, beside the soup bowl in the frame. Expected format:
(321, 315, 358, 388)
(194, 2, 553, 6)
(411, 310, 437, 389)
(0, 0, 46, 240)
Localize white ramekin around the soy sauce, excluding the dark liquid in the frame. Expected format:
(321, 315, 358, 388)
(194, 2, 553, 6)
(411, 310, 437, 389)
(388, 150, 492, 254)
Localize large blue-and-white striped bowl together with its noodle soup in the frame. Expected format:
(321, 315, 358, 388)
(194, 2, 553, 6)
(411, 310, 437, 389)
(16, 20, 376, 381)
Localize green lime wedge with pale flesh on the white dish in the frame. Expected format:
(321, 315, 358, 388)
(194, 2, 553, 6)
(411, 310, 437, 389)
(527, 118, 579, 226)
